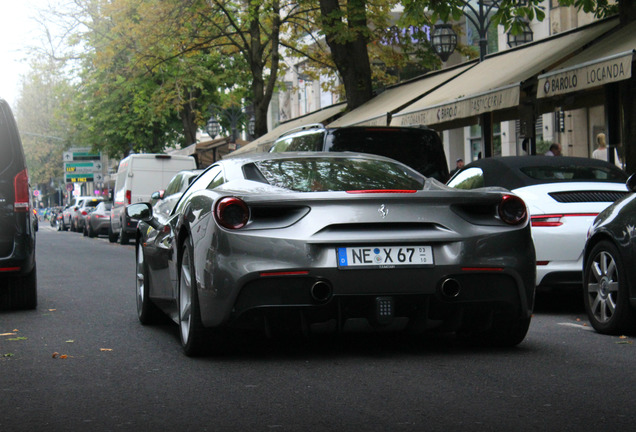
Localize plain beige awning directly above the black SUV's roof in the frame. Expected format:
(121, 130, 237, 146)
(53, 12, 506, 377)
(330, 61, 477, 127)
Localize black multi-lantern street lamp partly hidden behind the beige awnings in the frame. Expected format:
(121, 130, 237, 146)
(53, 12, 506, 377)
(431, 0, 533, 157)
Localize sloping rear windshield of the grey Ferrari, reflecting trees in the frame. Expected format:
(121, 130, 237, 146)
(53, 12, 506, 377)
(244, 158, 424, 192)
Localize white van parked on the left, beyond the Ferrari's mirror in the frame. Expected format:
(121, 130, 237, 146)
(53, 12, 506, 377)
(108, 154, 196, 244)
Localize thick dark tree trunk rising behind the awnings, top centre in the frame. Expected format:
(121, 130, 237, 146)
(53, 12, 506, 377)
(320, 0, 373, 110)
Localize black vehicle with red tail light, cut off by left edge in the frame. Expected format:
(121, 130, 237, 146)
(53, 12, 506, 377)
(0, 99, 37, 309)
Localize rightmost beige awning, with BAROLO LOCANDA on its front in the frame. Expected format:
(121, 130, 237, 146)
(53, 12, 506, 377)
(537, 22, 636, 98)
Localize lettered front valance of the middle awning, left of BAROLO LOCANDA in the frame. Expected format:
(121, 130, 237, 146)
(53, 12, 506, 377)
(392, 83, 520, 126)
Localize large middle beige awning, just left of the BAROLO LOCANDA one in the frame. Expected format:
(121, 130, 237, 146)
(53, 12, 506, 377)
(391, 19, 618, 126)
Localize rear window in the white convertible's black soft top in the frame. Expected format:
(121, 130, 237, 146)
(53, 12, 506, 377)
(520, 165, 625, 183)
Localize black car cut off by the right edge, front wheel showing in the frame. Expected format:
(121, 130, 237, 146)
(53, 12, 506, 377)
(583, 176, 636, 335)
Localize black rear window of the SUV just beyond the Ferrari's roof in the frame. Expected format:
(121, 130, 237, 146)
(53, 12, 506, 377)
(329, 128, 448, 182)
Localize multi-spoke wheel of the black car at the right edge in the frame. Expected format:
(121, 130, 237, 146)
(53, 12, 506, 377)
(583, 240, 636, 334)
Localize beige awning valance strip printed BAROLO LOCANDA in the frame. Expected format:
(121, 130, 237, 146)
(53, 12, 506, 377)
(537, 51, 633, 98)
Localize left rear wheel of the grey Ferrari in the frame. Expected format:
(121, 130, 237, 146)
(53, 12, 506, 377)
(179, 238, 205, 356)
